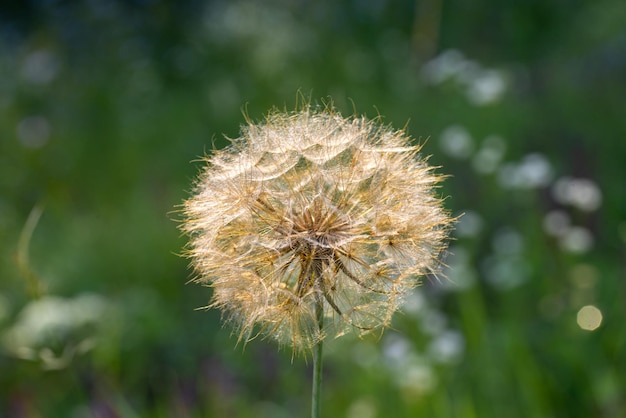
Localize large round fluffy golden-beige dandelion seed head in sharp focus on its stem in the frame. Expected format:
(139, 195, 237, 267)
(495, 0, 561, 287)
(182, 106, 451, 416)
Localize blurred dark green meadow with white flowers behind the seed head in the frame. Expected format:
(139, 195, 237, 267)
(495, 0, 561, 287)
(0, 0, 626, 418)
